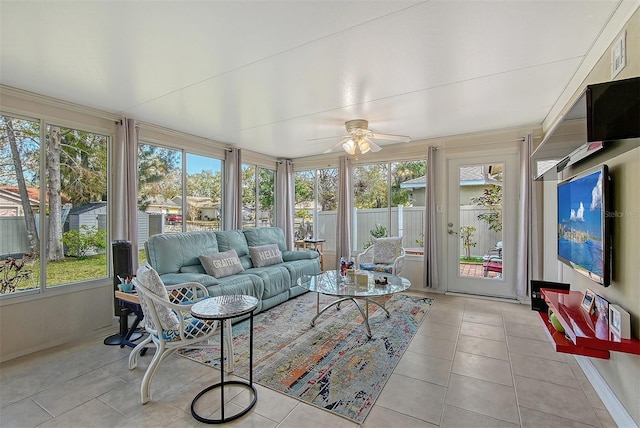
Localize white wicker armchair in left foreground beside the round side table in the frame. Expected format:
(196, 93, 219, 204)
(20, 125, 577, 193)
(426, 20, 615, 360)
(129, 263, 233, 404)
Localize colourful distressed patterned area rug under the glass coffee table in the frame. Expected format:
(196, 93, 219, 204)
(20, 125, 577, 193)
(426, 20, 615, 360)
(179, 293, 433, 423)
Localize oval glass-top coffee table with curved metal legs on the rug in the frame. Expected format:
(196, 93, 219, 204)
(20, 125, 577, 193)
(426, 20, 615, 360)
(298, 270, 411, 339)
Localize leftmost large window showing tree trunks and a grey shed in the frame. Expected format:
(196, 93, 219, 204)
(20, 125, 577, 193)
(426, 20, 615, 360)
(0, 116, 109, 294)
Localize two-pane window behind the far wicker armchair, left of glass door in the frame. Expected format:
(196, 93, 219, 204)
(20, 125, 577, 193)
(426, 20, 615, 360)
(352, 160, 426, 252)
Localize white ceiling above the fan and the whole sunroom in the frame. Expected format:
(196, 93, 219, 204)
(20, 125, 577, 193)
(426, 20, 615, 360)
(0, 0, 632, 158)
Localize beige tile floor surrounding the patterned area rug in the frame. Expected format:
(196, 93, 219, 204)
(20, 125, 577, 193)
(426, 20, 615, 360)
(0, 295, 615, 428)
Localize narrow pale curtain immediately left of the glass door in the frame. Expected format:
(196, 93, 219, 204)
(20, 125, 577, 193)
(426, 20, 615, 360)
(424, 146, 440, 289)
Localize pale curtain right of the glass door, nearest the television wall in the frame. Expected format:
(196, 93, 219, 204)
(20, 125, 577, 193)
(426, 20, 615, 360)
(516, 134, 533, 297)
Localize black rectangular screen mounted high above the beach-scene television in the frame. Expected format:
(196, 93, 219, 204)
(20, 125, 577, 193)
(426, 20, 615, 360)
(586, 77, 640, 142)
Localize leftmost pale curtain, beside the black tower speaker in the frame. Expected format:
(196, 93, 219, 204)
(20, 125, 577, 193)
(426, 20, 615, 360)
(111, 118, 138, 272)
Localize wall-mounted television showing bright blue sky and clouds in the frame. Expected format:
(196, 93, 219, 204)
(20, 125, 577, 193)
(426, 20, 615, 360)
(558, 165, 611, 287)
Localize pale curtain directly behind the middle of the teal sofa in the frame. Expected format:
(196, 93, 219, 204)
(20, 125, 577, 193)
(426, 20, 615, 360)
(222, 147, 242, 230)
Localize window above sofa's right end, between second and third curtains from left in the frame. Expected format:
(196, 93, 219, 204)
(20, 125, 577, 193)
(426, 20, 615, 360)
(242, 164, 276, 229)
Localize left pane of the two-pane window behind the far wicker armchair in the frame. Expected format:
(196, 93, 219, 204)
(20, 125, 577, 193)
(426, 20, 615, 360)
(353, 164, 390, 252)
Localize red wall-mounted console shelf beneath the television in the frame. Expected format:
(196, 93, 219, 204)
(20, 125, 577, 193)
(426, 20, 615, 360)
(538, 288, 640, 359)
